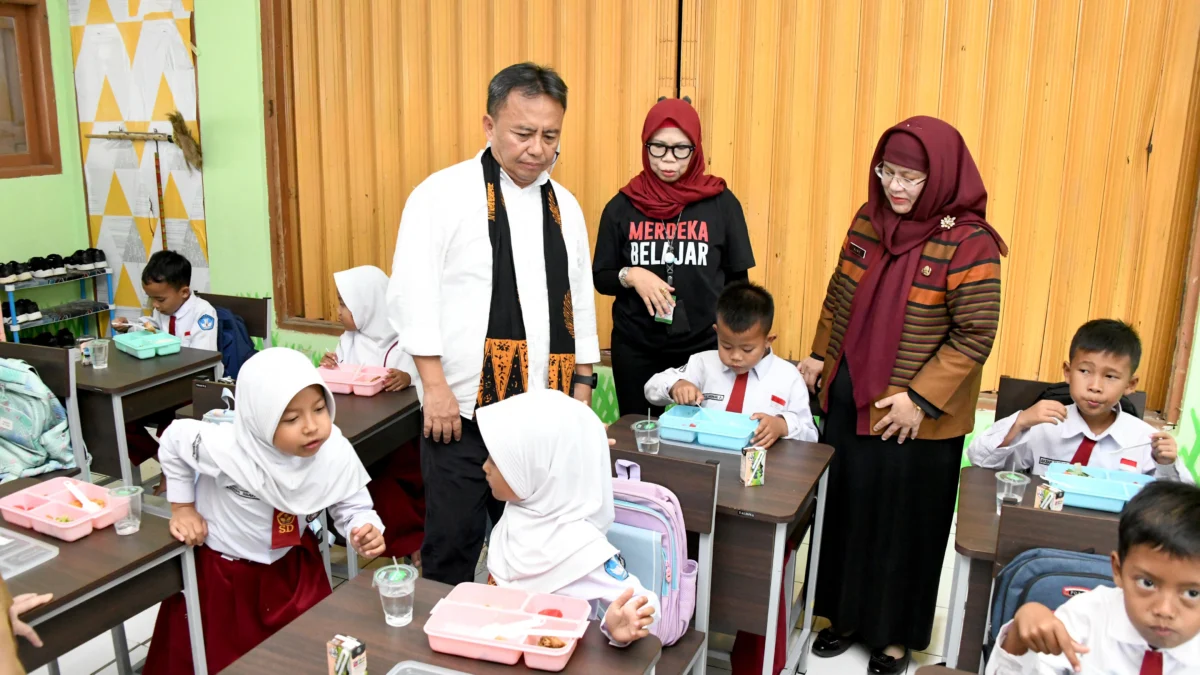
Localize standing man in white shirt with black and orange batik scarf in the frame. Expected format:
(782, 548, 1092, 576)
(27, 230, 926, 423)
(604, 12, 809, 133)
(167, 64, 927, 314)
(388, 64, 600, 584)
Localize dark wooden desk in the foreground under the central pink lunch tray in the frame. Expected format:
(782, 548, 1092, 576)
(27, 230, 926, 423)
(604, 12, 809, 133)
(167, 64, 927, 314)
(222, 574, 662, 675)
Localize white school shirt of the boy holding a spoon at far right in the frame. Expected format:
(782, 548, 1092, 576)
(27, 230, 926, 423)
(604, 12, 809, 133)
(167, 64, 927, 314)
(967, 404, 1195, 483)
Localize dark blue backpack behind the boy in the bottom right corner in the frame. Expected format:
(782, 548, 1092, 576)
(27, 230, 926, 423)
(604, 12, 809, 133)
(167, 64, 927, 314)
(988, 549, 1114, 647)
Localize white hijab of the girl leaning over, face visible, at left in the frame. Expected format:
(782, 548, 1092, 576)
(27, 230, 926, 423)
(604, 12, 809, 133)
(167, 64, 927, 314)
(182, 347, 371, 516)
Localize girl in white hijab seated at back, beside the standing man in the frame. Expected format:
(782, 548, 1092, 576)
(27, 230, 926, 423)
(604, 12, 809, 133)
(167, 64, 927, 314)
(320, 265, 425, 566)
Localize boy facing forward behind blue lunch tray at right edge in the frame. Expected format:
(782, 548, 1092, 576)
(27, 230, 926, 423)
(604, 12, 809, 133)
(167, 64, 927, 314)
(967, 318, 1195, 483)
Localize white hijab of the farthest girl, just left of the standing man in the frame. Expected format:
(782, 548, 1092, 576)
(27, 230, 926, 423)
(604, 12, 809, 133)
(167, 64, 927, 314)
(334, 265, 396, 366)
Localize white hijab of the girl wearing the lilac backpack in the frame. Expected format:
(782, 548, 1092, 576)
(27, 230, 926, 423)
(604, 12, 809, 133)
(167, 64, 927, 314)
(475, 389, 617, 593)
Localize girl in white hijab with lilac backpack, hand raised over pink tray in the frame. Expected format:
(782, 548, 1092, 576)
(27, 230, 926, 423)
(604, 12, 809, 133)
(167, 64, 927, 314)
(475, 389, 659, 646)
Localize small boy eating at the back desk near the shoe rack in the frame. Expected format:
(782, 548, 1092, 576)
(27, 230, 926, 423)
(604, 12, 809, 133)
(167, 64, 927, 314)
(113, 251, 221, 468)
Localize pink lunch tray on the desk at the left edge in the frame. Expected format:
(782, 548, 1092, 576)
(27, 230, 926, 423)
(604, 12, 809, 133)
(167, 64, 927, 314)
(0, 478, 130, 542)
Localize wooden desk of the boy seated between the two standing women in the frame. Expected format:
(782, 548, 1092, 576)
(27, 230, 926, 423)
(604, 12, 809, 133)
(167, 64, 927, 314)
(608, 416, 833, 673)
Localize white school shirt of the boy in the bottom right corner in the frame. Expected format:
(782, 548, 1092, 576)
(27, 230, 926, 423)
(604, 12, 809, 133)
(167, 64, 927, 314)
(985, 586, 1200, 675)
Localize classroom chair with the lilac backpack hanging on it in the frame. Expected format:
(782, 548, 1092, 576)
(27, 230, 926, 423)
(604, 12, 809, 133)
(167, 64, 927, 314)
(608, 448, 721, 675)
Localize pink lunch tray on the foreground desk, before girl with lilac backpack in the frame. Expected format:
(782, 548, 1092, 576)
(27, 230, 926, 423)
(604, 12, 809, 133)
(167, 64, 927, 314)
(425, 584, 592, 673)
